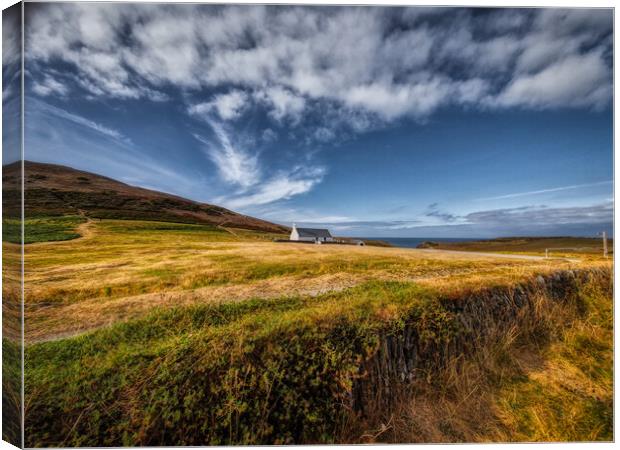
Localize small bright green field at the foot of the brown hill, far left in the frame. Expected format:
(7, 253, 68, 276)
(2, 216, 86, 244)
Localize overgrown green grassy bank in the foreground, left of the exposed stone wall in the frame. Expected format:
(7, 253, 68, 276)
(26, 283, 434, 446)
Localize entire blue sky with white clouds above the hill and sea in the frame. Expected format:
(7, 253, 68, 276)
(3, 3, 613, 237)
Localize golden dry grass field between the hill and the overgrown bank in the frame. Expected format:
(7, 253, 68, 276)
(17, 220, 605, 342)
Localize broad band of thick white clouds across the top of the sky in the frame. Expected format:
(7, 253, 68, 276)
(27, 3, 612, 131)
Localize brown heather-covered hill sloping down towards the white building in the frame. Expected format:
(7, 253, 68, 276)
(2, 161, 288, 233)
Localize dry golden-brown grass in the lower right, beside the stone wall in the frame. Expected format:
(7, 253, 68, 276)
(349, 273, 613, 443)
